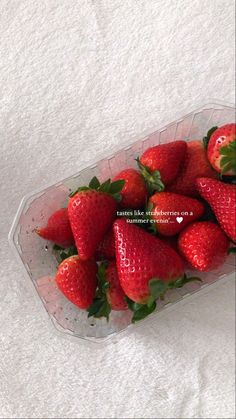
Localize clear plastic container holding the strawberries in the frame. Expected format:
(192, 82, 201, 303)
(9, 103, 235, 342)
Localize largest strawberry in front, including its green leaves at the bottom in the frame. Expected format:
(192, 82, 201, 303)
(114, 219, 199, 321)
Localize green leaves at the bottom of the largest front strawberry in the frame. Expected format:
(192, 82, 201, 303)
(126, 274, 202, 323)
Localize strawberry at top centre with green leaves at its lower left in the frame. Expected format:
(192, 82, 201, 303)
(137, 141, 187, 193)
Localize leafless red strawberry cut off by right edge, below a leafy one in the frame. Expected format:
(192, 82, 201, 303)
(196, 178, 236, 241)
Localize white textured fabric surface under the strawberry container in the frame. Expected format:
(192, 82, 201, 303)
(0, 0, 235, 418)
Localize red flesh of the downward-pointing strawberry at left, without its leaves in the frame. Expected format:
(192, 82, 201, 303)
(68, 190, 116, 260)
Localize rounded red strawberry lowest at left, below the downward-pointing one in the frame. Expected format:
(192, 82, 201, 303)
(56, 256, 97, 308)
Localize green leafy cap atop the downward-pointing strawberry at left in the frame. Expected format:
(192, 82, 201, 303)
(69, 176, 125, 202)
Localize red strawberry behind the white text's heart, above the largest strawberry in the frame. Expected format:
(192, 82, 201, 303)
(149, 192, 204, 236)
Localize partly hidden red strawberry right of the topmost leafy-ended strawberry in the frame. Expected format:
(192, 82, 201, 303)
(168, 140, 216, 196)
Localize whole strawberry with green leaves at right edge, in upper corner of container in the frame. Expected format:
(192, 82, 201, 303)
(203, 124, 236, 176)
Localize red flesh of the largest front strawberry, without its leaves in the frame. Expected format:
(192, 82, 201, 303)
(114, 219, 183, 304)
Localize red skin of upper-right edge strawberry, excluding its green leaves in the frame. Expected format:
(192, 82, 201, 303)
(207, 124, 236, 176)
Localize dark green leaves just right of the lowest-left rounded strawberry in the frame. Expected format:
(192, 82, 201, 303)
(87, 262, 111, 321)
